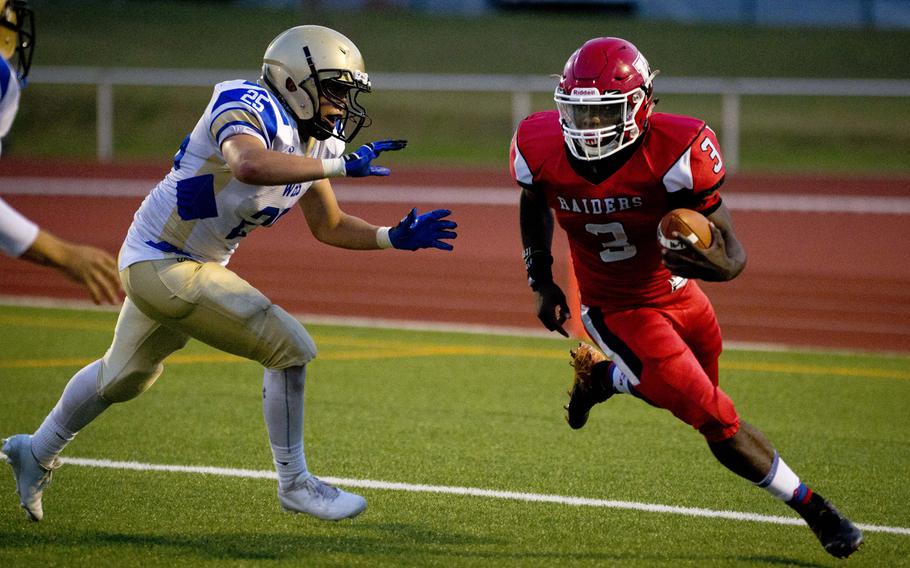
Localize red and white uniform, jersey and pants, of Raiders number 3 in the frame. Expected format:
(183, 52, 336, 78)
(510, 111, 739, 441)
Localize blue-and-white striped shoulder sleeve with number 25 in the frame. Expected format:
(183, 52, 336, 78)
(208, 85, 278, 148)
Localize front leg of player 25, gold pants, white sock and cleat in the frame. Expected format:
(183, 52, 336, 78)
(129, 260, 366, 519)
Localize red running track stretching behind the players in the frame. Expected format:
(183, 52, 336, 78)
(0, 160, 910, 352)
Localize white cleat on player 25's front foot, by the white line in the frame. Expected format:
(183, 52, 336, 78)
(278, 473, 367, 521)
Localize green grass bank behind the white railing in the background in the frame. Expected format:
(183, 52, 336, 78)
(4, 0, 910, 175)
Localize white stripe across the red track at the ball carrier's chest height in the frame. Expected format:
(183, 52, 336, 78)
(0, 177, 910, 215)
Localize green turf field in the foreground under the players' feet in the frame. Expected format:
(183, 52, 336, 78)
(0, 307, 910, 567)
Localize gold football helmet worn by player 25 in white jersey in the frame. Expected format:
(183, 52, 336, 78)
(261, 26, 370, 142)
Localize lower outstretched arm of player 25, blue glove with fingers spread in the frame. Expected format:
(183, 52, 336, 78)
(298, 180, 457, 250)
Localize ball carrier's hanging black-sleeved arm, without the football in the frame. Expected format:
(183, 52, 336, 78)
(518, 187, 571, 337)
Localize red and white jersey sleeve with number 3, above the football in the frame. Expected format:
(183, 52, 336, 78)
(663, 126, 726, 216)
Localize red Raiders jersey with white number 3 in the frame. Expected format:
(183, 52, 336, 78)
(509, 110, 725, 310)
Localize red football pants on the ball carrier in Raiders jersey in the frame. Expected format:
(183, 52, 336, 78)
(582, 282, 739, 442)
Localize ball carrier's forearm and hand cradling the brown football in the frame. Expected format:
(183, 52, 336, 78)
(663, 203, 746, 282)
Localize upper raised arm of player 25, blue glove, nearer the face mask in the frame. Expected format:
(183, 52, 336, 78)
(221, 134, 407, 185)
